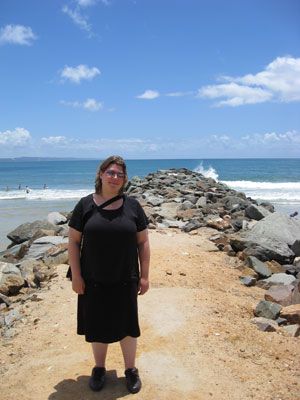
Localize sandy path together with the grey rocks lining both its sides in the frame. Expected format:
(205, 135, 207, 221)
(0, 169, 300, 400)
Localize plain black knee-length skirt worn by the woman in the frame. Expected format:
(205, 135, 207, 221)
(77, 282, 140, 343)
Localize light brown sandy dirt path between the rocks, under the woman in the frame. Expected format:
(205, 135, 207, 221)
(0, 229, 300, 400)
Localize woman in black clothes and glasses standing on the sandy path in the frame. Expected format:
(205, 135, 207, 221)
(69, 156, 150, 393)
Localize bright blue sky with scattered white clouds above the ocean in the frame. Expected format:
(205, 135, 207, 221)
(0, 0, 300, 158)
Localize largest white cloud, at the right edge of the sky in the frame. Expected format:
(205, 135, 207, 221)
(197, 57, 300, 107)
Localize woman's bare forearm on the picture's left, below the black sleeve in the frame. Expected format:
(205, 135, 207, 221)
(68, 227, 85, 294)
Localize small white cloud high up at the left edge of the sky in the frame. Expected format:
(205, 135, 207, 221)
(0, 25, 37, 46)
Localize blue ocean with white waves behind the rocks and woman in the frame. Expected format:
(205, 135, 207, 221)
(0, 158, 300, 249)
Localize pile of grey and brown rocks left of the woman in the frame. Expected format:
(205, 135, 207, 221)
(0, 212, 68, 338)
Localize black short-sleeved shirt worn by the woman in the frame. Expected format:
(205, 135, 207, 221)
(69, 194, 148, 283)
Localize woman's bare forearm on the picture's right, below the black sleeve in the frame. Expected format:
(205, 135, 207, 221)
(137, 229, 150, 294)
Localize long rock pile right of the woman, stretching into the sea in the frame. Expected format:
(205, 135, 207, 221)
(127, 169, 300, 337)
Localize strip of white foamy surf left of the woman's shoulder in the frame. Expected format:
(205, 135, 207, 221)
(0, 189, 93, 201)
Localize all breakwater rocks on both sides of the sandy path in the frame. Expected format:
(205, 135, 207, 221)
(0, 168, 300, 336)
